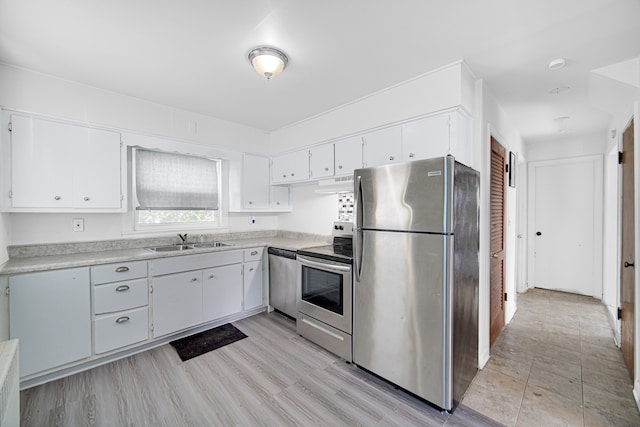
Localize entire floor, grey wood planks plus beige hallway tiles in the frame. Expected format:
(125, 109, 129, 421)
(21, 289, 640, 426)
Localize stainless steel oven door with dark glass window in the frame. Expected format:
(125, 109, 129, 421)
(298, 255, 352, 334)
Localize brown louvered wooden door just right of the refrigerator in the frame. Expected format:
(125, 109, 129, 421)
(489, 137, 506, 345)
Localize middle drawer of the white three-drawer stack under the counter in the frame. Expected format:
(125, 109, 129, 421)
(93, 278, 149, 314)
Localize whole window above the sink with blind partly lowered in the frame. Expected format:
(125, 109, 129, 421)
(134, 148, 220, 229)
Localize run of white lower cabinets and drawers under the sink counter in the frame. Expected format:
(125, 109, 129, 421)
(8, 247, 266, 384)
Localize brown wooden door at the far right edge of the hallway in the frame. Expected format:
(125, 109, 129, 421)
(620, 120, 635, 378)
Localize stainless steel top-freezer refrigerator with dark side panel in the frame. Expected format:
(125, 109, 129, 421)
(353, 156, 480, 410)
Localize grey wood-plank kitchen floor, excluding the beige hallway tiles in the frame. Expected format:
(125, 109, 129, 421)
(21, 313, 499, 426)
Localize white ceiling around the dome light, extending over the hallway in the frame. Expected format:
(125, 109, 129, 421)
(0, 0, 640, 142)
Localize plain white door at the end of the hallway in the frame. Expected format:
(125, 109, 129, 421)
(529, 156, 602, 298)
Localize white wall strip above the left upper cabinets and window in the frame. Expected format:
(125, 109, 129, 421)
(0, 64, 269, 154)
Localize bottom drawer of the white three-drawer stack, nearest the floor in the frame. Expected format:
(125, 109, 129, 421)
(93, 307, 149, 354)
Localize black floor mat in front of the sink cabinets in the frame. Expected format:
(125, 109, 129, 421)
(170, 323, 247, 362)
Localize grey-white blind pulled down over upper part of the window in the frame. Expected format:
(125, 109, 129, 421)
(136, 149, 218, 210)
